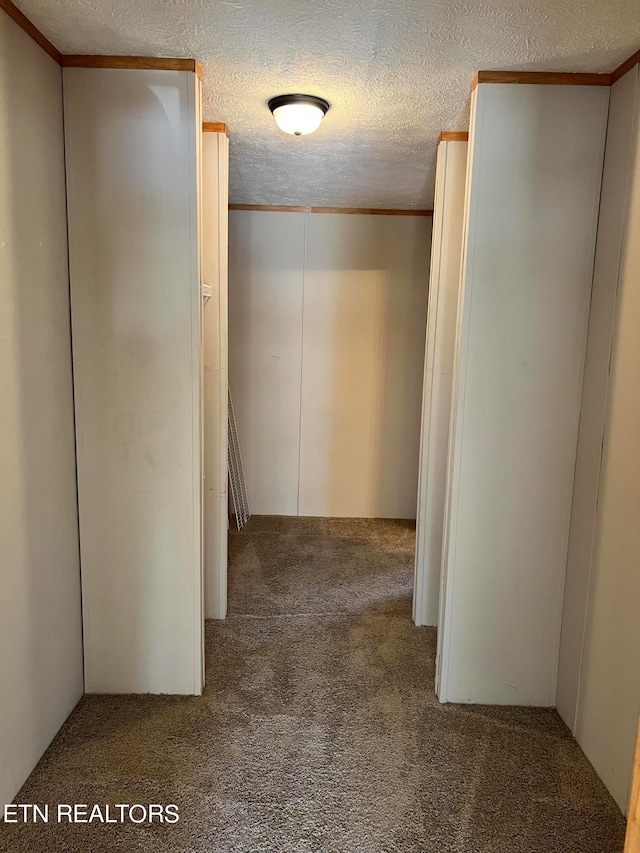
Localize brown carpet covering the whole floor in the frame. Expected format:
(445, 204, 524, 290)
(0, 517, 624, 853)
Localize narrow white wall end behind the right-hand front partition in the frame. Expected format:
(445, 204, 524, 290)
(413, 140, 469, 625)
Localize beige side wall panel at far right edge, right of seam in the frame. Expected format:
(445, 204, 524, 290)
(558, 66, 640, 810)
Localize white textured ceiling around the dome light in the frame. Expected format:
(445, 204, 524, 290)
(18, 0, 640, 208)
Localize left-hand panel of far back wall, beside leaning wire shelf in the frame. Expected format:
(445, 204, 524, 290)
(229, 211, 306, 515)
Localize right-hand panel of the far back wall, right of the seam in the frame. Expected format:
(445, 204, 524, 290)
(299, 214, 431, 518)
